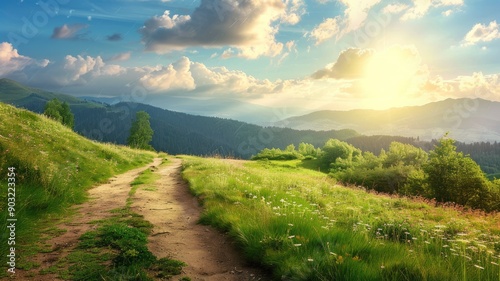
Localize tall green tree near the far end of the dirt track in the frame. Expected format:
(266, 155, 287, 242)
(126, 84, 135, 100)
(127, 111, 154, 150)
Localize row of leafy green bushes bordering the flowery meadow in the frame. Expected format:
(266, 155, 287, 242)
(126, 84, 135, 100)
(252, 136, 500, 211)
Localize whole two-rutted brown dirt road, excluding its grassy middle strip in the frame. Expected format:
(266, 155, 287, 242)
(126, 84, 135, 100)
(9, 158, 267, 281)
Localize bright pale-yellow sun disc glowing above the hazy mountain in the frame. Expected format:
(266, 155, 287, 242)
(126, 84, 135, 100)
(359, 47, 422, 109)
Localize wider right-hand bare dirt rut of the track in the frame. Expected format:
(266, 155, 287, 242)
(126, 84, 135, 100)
(132, 158, 265, 281)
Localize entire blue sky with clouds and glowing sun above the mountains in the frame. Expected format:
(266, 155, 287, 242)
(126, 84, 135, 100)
(0, 0, 500, 111)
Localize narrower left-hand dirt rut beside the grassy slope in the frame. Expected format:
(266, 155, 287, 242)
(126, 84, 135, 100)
(12, 158, 162, 281)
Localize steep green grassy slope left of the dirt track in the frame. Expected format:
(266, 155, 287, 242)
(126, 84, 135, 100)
(0, 101, 155, 268)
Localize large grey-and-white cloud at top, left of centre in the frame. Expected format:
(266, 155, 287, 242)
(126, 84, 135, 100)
(140, 0, 305, 59)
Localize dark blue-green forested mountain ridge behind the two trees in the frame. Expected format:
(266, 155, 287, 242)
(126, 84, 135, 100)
(0, 79, 359, 158)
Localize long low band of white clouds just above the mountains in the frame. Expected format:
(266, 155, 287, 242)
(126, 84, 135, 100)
(4, 41, 500, 110)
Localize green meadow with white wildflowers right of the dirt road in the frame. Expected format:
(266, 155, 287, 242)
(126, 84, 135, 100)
(183, 157, 500, 280)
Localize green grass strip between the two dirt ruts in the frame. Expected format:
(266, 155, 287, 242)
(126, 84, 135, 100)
(54, 165, 185, 281)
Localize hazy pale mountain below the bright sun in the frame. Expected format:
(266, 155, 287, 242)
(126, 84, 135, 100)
(274, 98, 500, 143)
